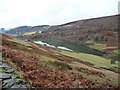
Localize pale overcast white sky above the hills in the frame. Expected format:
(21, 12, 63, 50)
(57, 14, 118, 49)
(0, 0, 119, 28)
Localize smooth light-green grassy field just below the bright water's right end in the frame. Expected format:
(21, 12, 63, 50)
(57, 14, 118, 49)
(60, 50, 118, 68)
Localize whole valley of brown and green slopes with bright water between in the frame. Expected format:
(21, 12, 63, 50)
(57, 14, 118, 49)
(0, 15, 120, 88)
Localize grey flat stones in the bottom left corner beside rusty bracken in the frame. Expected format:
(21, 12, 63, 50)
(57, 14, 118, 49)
(0, 61, 31, 89)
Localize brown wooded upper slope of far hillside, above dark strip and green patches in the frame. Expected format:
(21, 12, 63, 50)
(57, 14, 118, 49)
(20, 15, 120, 46)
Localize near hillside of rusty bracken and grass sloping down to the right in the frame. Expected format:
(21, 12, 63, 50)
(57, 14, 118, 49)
(0, 34, 118, 88)
